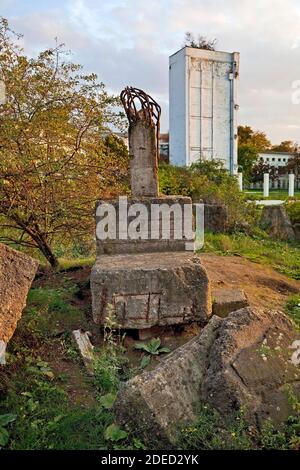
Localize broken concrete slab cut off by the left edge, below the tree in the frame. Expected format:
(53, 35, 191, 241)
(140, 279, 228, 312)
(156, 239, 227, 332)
(0, 244, 38, 343)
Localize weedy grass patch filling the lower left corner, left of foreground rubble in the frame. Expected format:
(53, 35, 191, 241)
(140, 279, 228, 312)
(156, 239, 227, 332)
(0, 277, 137, 450)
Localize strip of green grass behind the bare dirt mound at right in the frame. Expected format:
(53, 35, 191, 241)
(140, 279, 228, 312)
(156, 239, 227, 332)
(204, 232, 300, 279)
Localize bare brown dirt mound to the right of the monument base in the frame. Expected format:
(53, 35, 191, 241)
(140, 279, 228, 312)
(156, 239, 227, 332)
(200, 253, 300, 310)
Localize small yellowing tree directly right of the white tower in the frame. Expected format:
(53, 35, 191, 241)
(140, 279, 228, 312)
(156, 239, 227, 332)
(238, 126, 271, 180)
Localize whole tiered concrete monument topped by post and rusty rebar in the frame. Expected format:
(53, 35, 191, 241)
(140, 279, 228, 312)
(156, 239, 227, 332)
(91, 87, 211, 330)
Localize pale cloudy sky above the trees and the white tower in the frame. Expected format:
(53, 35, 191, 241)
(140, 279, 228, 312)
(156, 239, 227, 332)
(0, 0, 300, 144)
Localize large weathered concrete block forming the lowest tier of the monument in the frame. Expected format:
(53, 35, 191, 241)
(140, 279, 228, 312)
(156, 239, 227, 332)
(91, 252, 211, 329)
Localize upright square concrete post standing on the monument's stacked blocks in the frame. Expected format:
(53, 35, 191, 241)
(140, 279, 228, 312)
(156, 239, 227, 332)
(129, 119, 158, 196)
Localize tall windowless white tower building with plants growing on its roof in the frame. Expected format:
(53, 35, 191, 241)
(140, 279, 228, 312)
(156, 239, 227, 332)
(169, 47, 239, 173)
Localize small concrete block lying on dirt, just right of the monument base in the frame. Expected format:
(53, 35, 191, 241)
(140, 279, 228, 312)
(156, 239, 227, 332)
(212, 289, 249, 318)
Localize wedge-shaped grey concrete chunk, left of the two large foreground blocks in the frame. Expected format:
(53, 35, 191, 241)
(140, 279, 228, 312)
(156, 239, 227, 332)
(114, 317, 222, 449)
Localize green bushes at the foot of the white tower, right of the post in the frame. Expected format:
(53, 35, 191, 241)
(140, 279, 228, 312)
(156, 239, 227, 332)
(159, 161, 256, 230)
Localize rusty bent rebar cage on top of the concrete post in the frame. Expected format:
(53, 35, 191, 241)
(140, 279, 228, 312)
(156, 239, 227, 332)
(120, 86, 161, 160)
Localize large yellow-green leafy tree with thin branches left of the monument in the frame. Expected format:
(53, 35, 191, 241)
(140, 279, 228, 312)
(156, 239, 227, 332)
(0, 18, 128, 267)
